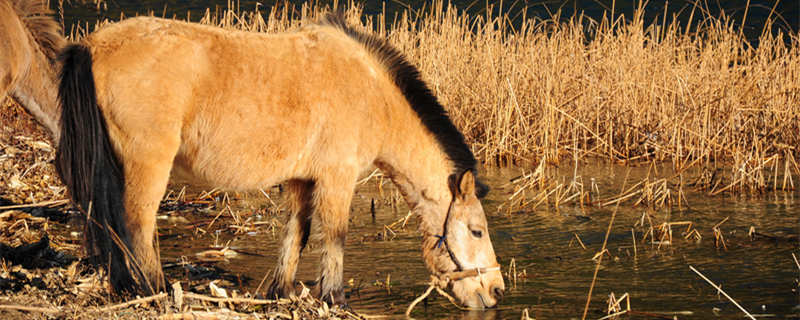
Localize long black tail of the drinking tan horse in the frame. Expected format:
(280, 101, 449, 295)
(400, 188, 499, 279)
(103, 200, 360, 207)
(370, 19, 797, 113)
(56, 44, 152, 292)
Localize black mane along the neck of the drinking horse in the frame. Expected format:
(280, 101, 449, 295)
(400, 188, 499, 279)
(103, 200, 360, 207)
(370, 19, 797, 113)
(322, 14, 477, 177)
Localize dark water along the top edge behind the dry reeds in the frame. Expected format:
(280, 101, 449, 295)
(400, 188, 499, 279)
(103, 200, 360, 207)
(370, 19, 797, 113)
(59, 0, 800, 45)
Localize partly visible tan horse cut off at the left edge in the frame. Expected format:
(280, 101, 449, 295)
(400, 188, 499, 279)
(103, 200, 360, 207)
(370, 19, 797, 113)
(0, 0, 66, 143)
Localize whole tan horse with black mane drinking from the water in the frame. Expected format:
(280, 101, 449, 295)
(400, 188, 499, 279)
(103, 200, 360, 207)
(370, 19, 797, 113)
(56, 15, 504, 308)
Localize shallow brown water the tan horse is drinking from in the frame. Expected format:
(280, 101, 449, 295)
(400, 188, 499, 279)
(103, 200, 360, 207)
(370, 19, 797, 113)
(156, 166, 800, 319)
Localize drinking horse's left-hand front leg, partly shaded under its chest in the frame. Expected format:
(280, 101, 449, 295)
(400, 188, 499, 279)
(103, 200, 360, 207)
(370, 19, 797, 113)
(267, 180, 314, 298)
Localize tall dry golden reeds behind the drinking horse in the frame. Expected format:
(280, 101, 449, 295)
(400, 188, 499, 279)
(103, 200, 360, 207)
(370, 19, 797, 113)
(133, 1, 800, 207)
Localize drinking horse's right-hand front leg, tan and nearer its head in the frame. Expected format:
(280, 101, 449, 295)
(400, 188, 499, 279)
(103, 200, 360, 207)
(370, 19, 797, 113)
(314, 169, 357, 305)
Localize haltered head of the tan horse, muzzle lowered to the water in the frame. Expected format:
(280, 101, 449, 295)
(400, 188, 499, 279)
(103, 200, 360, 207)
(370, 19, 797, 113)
(423, 170, 505, 308)
